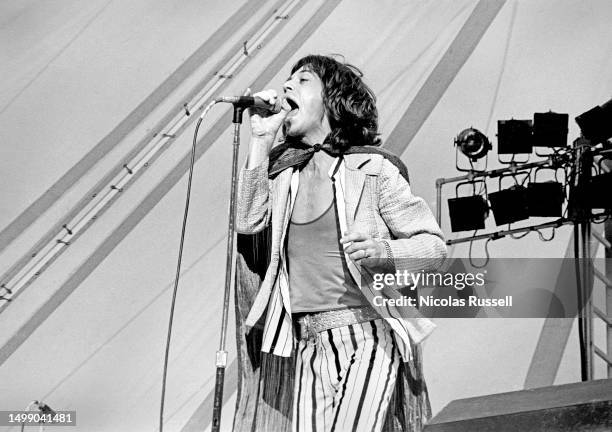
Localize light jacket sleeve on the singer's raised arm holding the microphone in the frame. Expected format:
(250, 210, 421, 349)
(236, 159, 271, 234)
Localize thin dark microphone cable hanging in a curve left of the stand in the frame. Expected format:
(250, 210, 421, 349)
(159, 100, 219, 432)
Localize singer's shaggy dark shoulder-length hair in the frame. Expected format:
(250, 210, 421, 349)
(291, 55, 380, 151)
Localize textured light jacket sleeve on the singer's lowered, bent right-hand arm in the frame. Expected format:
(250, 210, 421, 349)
(378, 159, 447, 271)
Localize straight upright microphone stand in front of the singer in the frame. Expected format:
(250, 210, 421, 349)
(212, 103, 244, 432)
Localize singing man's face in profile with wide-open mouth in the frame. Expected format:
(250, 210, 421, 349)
(283, 67, 330, 144)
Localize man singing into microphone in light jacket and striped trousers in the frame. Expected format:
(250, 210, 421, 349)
(236, 55, 446, 431)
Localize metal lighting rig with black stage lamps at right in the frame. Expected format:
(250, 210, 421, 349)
(436, 100, 612, 381)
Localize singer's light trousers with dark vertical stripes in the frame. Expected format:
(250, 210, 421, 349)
(292, 319, 401, 432)
